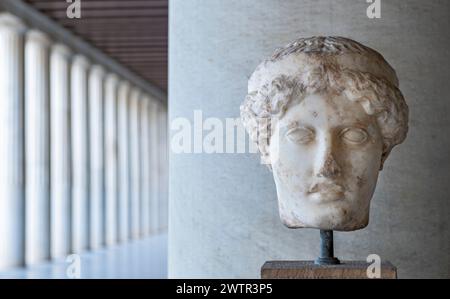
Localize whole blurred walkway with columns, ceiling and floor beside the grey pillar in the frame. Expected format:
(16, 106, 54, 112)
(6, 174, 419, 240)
(0, 0, 168, 278)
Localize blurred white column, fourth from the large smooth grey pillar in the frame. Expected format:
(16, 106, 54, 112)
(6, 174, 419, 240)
(129, 88, 141, 239)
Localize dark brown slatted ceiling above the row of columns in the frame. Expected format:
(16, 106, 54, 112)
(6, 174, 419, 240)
(26, 0, 168, 92)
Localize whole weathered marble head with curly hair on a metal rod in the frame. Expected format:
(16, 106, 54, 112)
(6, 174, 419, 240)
(241, 37, 408, 231)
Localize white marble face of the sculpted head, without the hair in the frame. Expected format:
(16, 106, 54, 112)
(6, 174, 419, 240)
(269, 93, 383, 231)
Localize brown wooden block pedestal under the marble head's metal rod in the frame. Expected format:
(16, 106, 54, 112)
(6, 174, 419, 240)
(261, 261, 397, 279)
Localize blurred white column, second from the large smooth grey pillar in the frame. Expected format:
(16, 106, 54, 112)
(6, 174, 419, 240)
(150, 101, 160, 233)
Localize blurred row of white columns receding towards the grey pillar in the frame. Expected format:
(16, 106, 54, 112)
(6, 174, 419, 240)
(0, 12, 167, 270)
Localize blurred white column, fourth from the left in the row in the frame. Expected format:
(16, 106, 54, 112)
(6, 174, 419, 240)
(70, 55, 89, 253)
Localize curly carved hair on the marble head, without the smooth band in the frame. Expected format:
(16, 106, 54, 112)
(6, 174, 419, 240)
(240, 37, 408, 167)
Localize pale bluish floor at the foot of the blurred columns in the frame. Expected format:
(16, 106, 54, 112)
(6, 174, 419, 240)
(0, 234, 167, 279)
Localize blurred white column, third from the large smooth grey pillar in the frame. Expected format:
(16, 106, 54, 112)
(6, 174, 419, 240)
(139, 96, 150, 236)
